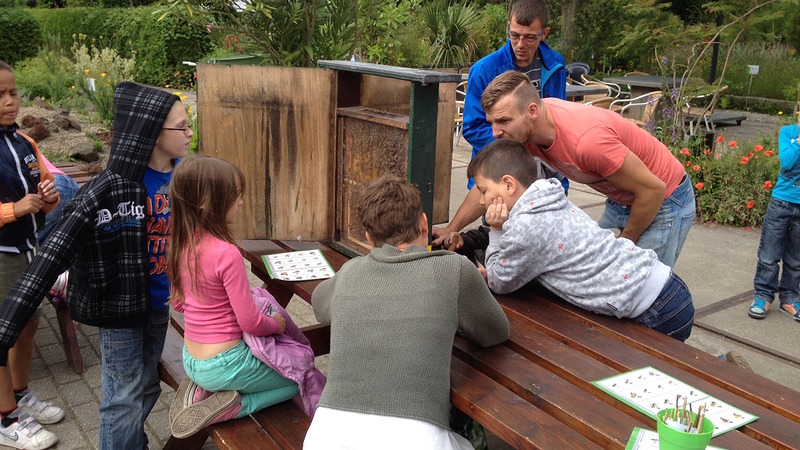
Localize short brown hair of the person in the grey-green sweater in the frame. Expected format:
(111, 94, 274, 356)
(356, 174, 422, 247)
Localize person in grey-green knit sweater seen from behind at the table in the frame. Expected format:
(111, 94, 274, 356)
(303, 175, 509, 450)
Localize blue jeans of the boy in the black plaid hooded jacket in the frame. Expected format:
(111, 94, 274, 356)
(100, 308, 169, 450)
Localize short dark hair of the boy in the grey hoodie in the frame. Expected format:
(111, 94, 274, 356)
(467, 139, 538, 188)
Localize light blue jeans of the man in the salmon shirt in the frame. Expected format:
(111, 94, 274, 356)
(598, 175, 695, 267)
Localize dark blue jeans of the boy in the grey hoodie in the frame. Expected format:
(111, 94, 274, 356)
(633, 273, 694, 342)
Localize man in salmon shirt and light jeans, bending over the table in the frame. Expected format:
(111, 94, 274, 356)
(481, 71, 695, 267)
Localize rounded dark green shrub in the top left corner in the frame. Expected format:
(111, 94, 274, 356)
(0, 8, 42, 65)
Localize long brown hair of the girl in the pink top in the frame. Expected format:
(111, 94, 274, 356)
(167, 155, 245, 304)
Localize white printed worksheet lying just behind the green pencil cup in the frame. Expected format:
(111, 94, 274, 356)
(592, 366, 758, 437)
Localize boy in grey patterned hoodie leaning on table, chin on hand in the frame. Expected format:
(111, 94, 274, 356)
(467, 139, 694, 341)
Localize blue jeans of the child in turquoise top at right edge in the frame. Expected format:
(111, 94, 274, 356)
(753, 198, 800, 303)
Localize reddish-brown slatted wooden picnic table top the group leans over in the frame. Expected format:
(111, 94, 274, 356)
(239, 240, 800, 449)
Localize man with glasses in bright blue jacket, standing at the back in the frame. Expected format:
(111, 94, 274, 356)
(433, 0, 569, 245)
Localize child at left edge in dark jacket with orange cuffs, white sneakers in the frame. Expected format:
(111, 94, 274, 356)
(0, 61, 64, 449)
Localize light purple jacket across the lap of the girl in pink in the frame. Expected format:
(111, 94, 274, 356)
(244, 288, 326, 418)
